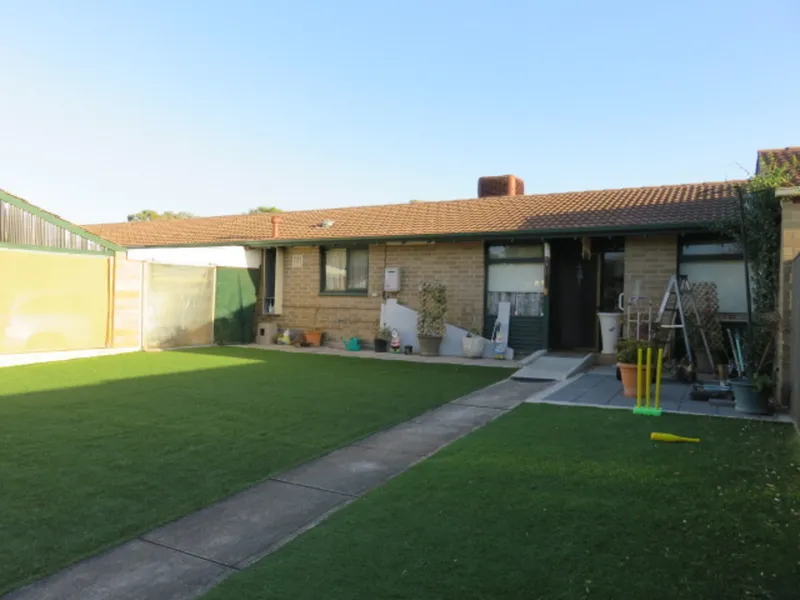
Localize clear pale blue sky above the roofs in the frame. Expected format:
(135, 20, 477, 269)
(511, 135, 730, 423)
(0, 0, 800, 223)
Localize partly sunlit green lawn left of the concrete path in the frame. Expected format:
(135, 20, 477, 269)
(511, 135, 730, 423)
(0, 348, 509, 594)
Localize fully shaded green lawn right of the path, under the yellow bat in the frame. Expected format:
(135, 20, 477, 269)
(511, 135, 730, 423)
(204, 405, 800, 600)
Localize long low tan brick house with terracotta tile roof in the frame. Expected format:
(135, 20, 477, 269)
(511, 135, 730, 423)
(89, 175, 760, 354)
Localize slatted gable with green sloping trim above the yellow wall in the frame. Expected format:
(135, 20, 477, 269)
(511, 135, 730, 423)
(0, 189, 122, 252)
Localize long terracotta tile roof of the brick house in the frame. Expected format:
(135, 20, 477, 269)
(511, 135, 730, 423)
(86, 181, 743, 247)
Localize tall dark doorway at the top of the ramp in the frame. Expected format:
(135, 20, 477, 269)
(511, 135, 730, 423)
(550, 240, 598, 349)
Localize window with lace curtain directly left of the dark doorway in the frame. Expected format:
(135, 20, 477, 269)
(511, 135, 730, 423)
(486, 244, 544, 317)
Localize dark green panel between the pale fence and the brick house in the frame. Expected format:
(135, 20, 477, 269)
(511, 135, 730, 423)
(214, 267, 261, 344)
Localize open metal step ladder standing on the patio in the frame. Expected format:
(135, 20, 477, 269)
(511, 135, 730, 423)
(657, 275, 714, 367)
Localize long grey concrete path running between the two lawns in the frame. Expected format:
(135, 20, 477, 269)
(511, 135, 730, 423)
(5, 380, 550, 600)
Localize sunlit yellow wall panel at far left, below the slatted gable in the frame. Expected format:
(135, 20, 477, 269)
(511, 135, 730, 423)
(0, 249, 111, 353)
